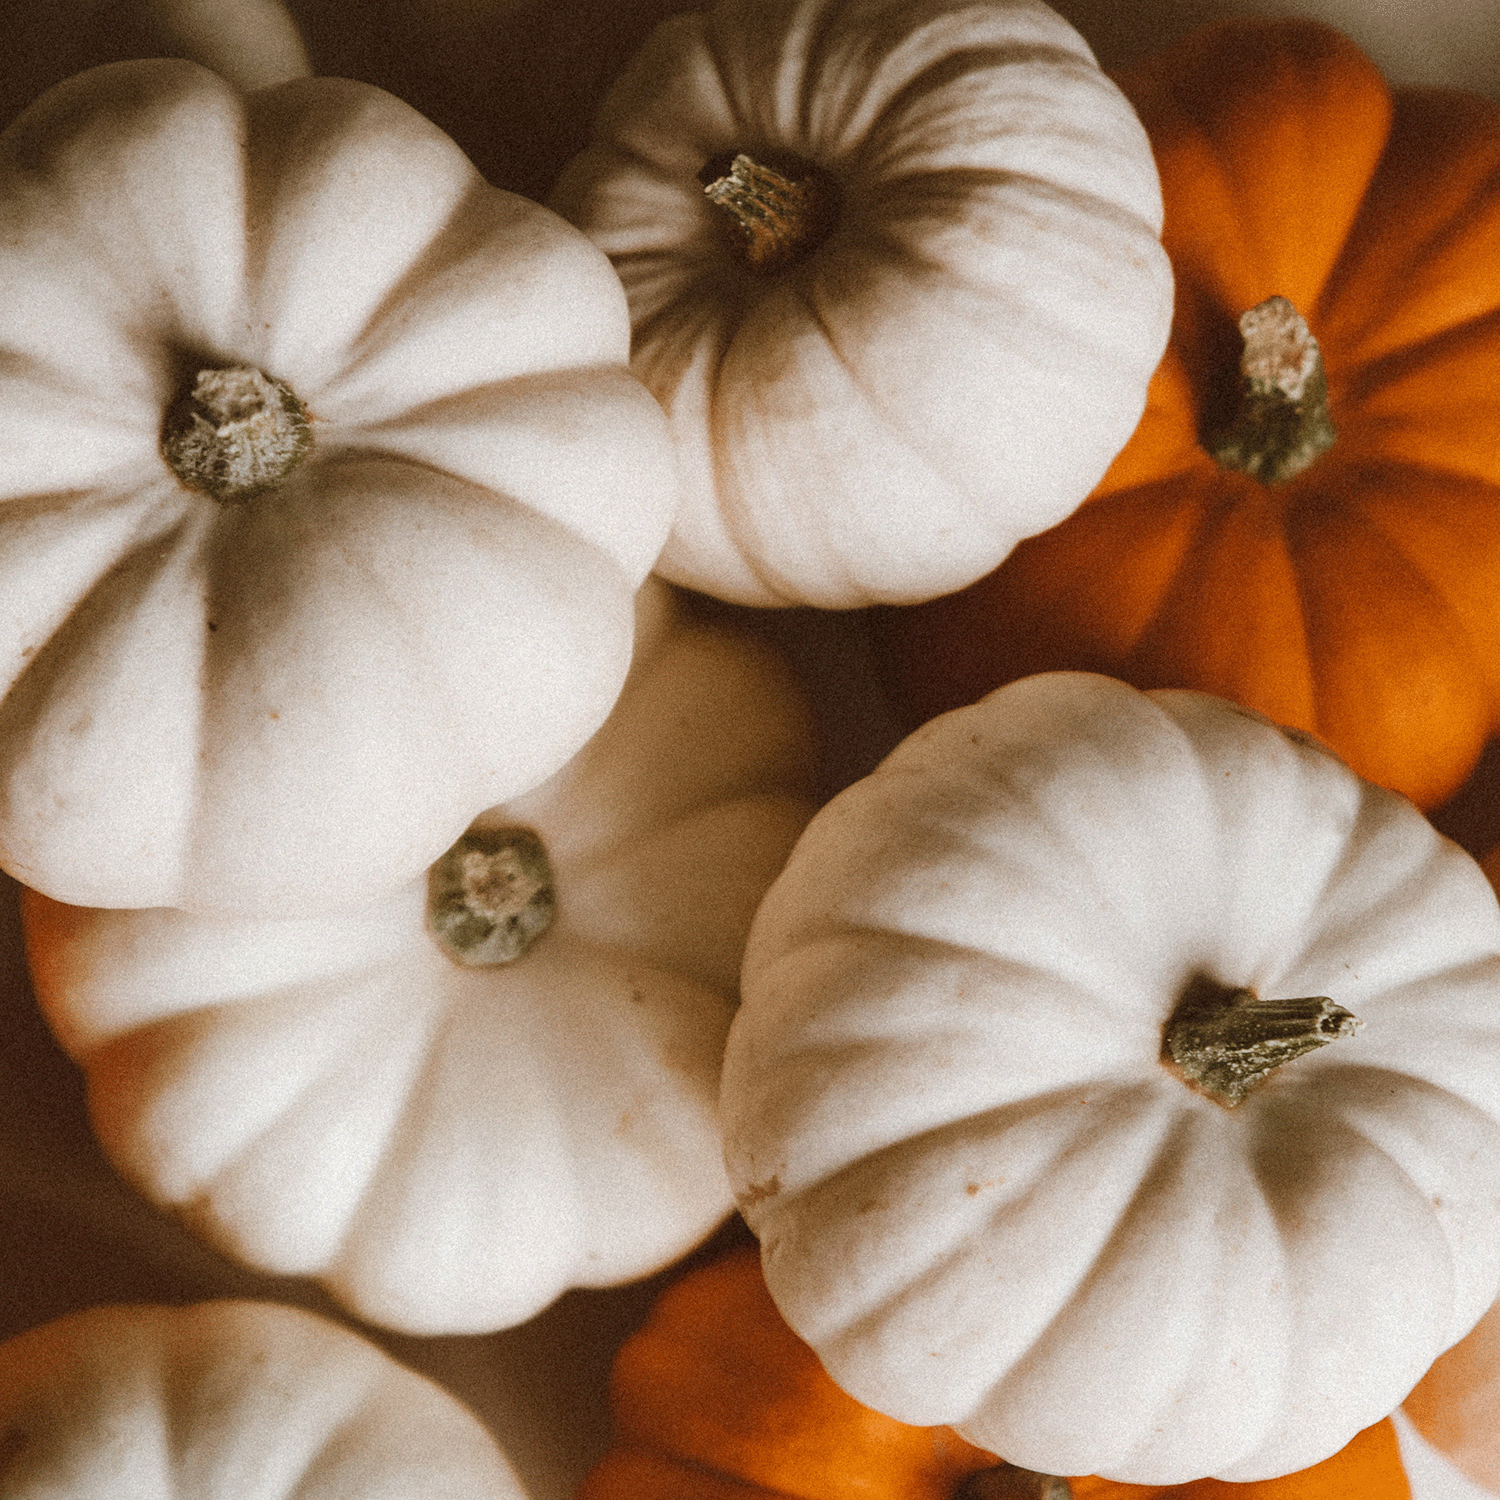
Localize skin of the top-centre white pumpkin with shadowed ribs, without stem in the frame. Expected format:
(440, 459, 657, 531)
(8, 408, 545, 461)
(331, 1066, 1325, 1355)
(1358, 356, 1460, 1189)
(549, 0, 1172, 608)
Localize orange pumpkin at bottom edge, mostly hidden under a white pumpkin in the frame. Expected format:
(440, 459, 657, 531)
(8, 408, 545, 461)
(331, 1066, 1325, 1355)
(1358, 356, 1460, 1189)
(576, 1245, 1410, 1500)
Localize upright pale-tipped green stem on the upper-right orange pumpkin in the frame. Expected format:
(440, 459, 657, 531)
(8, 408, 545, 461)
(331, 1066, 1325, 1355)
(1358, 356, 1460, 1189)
(1205, 297, 1337, 485)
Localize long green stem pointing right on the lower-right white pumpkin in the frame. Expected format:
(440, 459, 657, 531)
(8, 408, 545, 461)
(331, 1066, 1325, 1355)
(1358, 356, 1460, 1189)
(1161, 984, 1361, 1109)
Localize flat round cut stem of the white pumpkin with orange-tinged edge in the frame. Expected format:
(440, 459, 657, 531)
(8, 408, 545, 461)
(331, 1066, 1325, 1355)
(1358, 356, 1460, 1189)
(428, 828, 557, 968)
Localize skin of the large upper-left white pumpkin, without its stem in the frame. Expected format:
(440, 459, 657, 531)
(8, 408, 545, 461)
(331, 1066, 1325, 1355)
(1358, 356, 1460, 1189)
(0, 60, 677, 915)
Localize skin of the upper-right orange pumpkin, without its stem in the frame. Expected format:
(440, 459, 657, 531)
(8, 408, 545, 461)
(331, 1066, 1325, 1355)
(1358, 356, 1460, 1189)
(878, 18, 1500, 807)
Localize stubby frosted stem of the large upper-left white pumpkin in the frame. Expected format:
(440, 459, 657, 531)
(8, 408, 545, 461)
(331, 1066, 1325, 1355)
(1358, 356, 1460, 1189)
(162, 365, 312, 501)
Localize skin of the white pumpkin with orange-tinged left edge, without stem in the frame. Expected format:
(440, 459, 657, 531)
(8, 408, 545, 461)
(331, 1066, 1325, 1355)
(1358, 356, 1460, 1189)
(23, 585, 816, 1334)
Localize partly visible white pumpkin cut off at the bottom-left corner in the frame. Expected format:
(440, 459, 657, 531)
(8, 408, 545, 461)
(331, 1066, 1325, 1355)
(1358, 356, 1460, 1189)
(0, 1301, 525, 1500)
